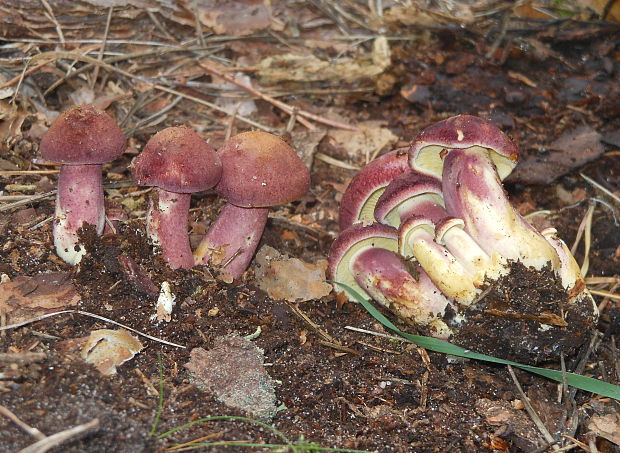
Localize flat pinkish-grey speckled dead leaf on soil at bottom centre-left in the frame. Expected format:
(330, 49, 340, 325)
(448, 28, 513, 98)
(185, 336, 276, 420)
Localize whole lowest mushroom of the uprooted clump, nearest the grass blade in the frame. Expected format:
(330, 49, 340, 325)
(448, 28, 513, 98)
(327, 223, 451, 338)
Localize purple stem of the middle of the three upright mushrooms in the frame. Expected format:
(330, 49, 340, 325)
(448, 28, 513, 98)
(146, 188, 194, 269)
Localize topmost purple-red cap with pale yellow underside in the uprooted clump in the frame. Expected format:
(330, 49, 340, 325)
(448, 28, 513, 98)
(409, 115, 519, 180)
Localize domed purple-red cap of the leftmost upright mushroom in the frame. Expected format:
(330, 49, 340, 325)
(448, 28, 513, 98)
(40, 105, 125, 165)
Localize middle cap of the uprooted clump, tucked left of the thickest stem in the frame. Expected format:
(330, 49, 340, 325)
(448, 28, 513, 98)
(374, 171, 447, 228)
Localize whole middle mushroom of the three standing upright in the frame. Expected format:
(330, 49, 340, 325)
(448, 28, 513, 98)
(132, 126, 222, 269)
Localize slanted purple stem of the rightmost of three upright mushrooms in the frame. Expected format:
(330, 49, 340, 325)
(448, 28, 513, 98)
(194, 203, 269, 278)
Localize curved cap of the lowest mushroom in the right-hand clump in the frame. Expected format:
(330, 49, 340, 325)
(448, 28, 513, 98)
(327, 223, 398, 300)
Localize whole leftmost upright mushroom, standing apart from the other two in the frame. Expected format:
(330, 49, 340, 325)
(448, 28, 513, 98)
(40, 105, 125, 265)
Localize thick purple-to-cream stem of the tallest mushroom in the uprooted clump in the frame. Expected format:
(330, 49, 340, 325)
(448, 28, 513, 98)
(443, 146, 559, 269)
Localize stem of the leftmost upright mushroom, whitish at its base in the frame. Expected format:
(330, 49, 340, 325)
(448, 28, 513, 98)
(53, 164, 105, 265)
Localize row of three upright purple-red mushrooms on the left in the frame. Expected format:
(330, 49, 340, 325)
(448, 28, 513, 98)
(41, 105, 310, 278)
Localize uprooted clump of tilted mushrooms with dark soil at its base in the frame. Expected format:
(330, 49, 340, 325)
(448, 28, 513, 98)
(328, 115, 597, 361)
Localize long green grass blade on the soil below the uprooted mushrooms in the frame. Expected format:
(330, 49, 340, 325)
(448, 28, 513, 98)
(332, 282, 620, 400)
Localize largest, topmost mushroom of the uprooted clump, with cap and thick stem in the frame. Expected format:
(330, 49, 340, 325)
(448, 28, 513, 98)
(409, 115, 559, 270)
